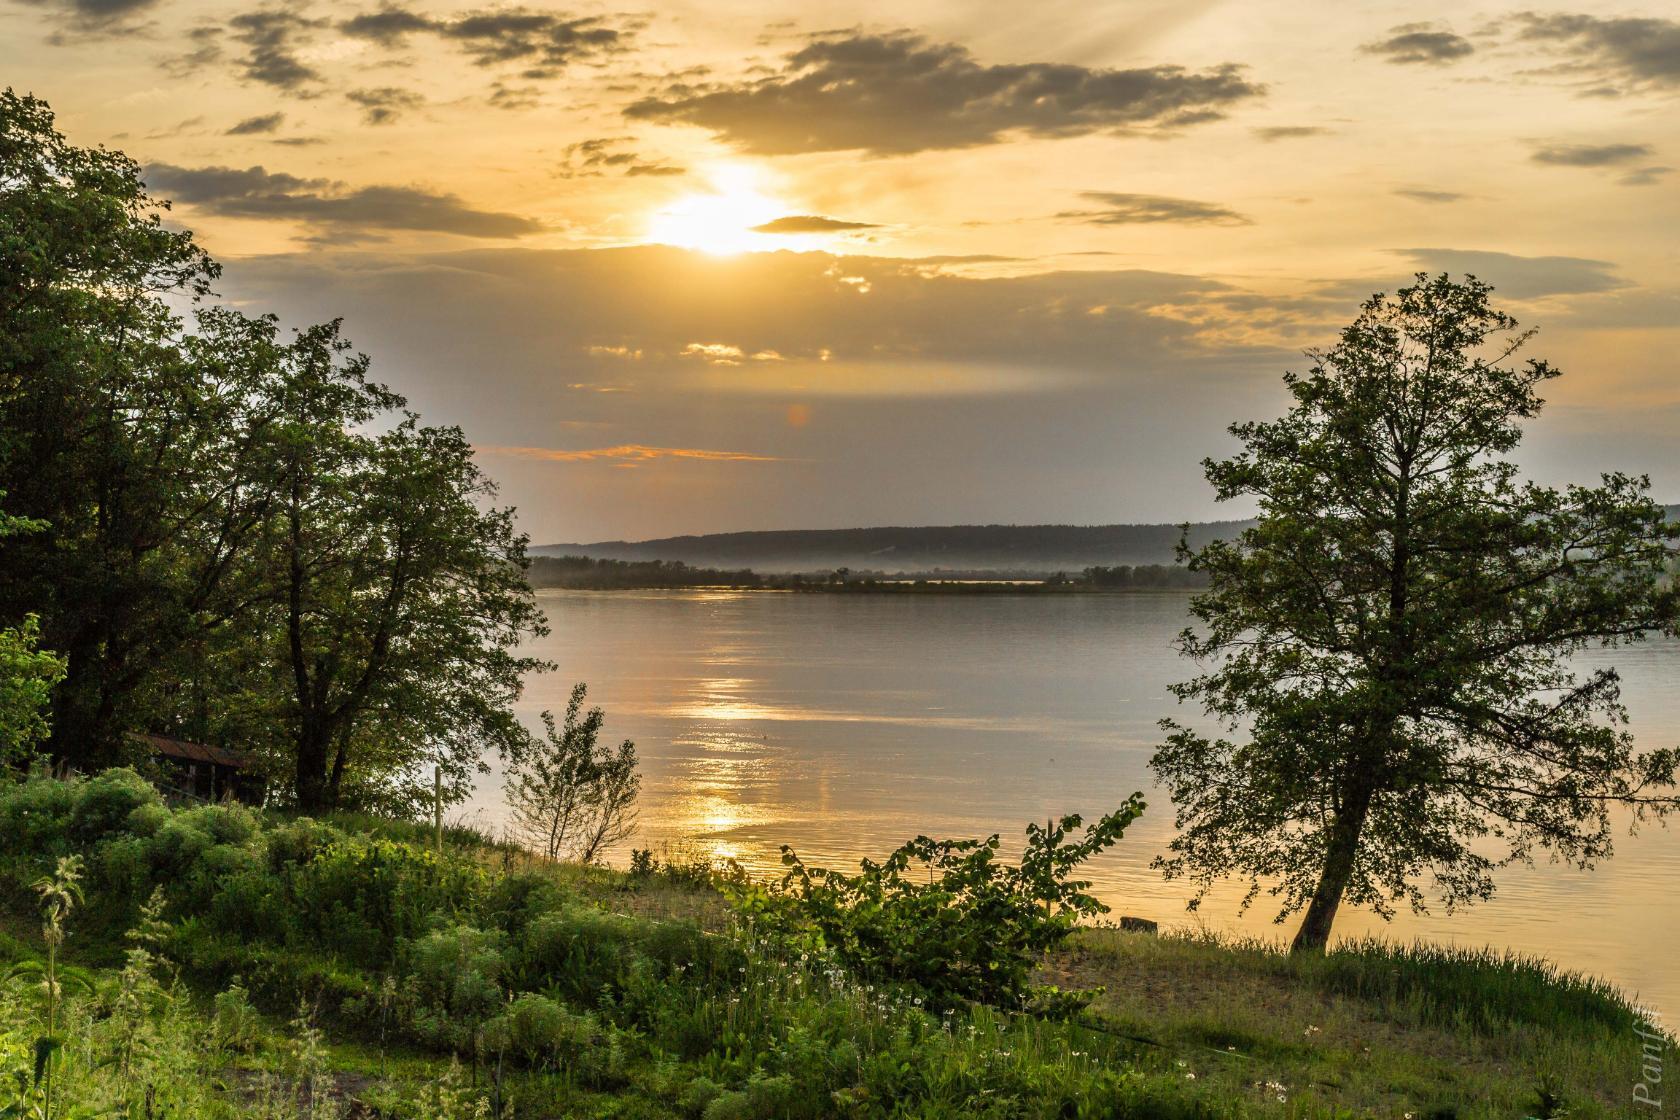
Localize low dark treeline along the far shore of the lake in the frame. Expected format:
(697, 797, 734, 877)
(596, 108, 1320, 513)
(529, 556, 1206, 593)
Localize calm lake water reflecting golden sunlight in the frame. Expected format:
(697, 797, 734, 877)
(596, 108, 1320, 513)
(474, 591, 1680, 1014)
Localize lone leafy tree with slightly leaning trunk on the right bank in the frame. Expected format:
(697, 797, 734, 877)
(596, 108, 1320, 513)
(1152, 274, 1680, 950)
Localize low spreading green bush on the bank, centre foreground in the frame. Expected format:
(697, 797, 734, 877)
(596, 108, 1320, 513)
(736, 794, 1144, 1013)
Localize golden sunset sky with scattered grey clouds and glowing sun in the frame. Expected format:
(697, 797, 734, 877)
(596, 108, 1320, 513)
(0, 0, 1680, 542)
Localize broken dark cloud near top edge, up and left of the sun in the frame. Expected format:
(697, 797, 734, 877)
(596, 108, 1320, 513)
(339, 5, 628, 79)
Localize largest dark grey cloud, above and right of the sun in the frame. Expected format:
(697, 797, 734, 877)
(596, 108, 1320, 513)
(625, 34, 1263, 156)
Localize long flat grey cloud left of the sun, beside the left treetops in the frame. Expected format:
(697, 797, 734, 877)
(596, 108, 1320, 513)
(146, 163, 543, 238)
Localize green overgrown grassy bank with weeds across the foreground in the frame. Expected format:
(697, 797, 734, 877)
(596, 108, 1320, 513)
(0, 772, 1641, 1120)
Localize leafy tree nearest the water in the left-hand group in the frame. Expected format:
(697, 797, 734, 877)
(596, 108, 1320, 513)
(228, 321, 546, 811)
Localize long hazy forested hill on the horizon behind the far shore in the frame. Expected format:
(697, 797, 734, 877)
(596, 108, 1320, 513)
(531, 505, 1680, 574)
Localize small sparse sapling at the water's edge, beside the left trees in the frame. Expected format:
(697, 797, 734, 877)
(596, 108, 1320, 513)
(504, 683, 642, 863)
